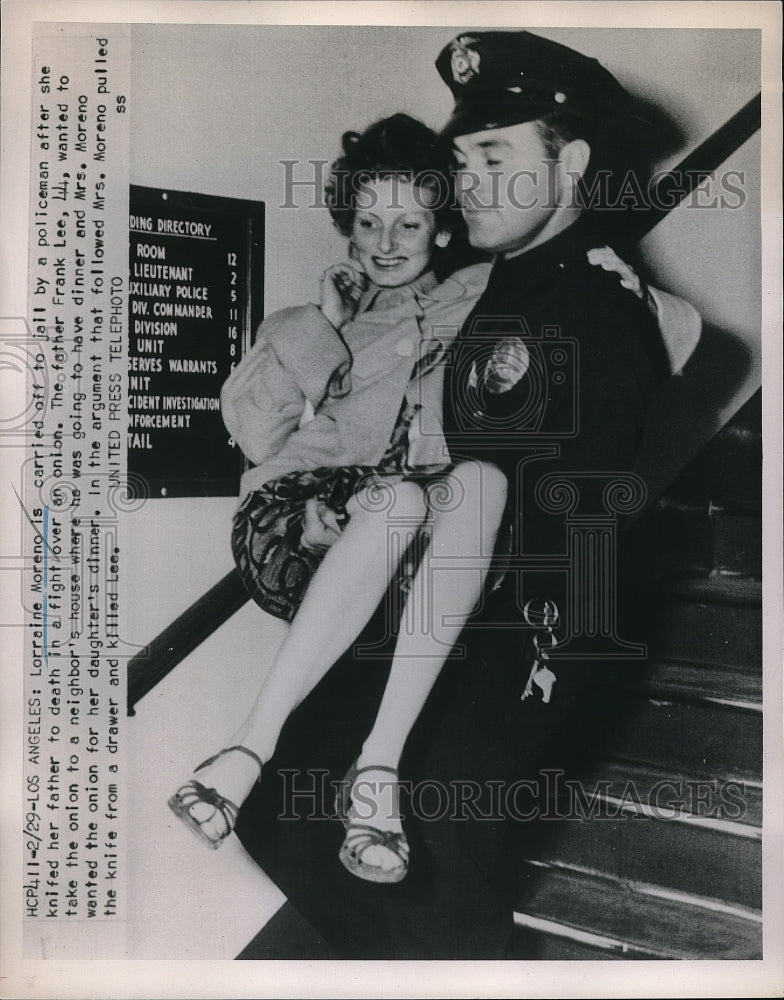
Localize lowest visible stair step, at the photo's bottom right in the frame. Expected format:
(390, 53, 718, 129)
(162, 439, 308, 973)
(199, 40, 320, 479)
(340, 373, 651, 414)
(515, 862, 762, 960)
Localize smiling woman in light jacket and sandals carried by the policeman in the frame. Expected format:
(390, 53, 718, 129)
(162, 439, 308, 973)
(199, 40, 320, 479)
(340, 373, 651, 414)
(169, 115, 699, 882)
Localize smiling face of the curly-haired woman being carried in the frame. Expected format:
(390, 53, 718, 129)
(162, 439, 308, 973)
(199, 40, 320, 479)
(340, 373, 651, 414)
(351, 177, 449, 288)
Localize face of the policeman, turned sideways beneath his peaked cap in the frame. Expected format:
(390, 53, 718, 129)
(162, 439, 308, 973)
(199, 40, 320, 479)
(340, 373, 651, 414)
(454, 122, 558, 254)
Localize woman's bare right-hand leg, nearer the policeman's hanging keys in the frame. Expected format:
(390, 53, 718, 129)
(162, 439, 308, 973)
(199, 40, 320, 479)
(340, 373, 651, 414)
(348, 462, 507, 868)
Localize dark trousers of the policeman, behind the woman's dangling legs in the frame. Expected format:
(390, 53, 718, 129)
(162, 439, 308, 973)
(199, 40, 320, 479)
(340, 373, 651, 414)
(237, 596, 591, 959)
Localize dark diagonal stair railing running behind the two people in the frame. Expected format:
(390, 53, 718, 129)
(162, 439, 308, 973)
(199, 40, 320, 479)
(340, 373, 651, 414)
(128, 94, 762, 715)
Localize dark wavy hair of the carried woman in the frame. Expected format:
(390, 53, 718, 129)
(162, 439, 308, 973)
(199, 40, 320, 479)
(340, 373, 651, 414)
(324, 114, 460, 236)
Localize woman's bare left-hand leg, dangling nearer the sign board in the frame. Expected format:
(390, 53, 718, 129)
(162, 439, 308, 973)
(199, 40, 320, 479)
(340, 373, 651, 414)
(178, 483, 427, 835)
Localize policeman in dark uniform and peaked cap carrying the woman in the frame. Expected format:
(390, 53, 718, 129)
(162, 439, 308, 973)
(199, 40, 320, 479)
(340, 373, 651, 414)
(239, 31, 667, 959)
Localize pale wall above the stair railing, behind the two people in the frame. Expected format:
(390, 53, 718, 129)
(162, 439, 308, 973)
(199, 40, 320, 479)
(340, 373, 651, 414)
(124, 25, 760, 640)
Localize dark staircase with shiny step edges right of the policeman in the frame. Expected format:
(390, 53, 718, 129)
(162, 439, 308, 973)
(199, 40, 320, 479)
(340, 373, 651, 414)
(510, 393, 762, 959)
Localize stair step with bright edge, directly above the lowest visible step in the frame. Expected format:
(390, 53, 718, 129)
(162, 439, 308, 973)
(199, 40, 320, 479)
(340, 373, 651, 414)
(523, 761, 762, 908)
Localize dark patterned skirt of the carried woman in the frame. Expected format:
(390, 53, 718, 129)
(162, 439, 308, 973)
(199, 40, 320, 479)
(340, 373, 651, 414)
(231, 401, 433, 622)
